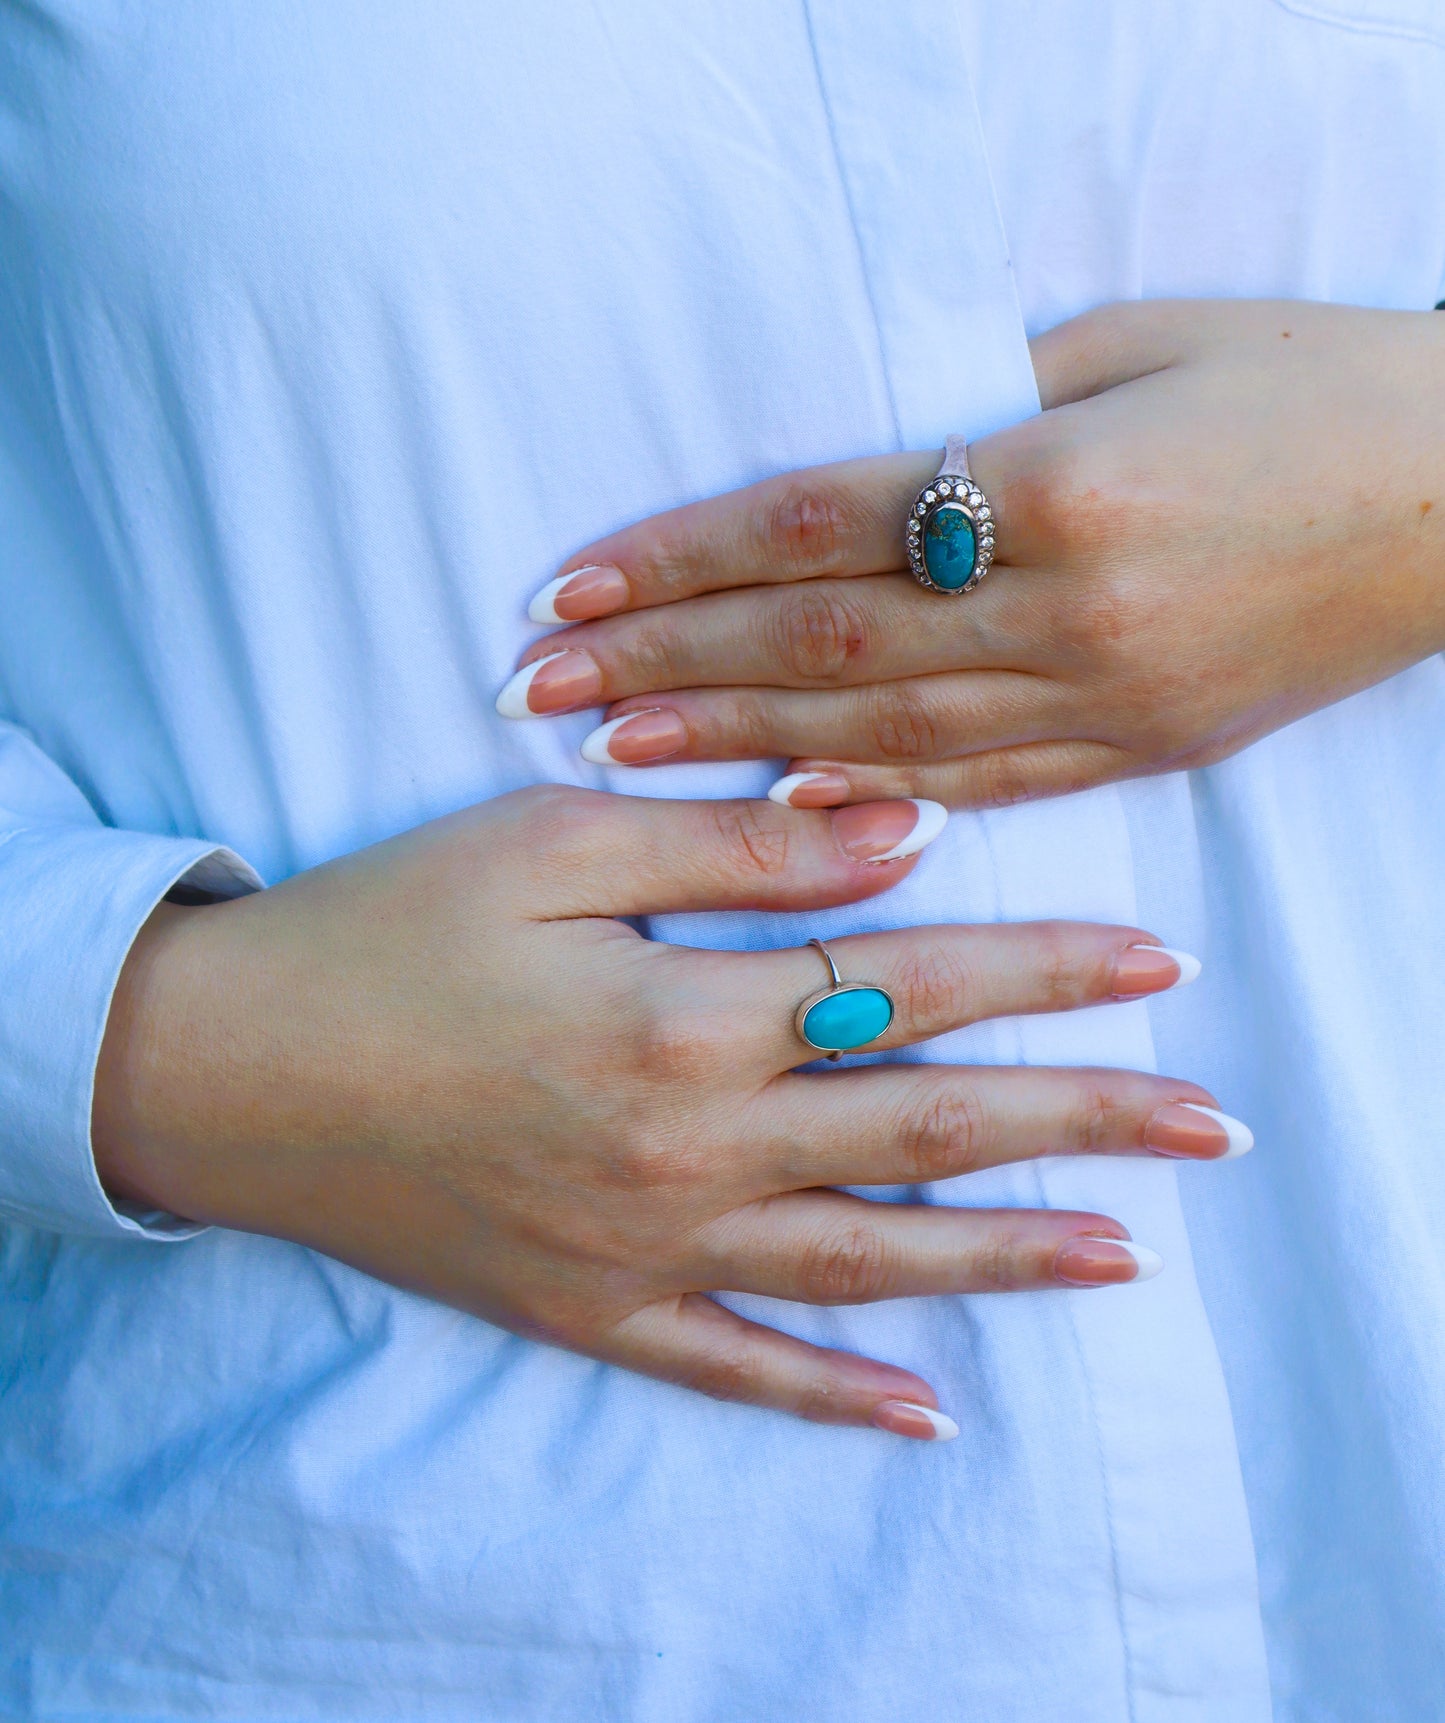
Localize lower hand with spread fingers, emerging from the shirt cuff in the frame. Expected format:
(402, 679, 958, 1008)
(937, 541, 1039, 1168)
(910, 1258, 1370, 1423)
(95, 789, 1242, 1435)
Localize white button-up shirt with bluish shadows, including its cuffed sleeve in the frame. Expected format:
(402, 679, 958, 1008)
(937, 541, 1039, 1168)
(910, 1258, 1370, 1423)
(0, 0, 1445, 1723)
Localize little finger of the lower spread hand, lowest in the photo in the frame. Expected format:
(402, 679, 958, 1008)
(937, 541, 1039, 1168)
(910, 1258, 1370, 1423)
(598, 1294, 958, 1440)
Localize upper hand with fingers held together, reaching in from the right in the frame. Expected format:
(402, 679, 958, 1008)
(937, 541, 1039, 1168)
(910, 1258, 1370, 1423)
(499, 302, 1445, 806)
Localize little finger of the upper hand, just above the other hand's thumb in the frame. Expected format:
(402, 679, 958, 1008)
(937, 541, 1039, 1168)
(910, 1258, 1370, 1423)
(768, 741, 1142, 808)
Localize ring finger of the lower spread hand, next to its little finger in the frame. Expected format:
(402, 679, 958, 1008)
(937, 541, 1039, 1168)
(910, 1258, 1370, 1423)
(696, 1191, 1163, 1304)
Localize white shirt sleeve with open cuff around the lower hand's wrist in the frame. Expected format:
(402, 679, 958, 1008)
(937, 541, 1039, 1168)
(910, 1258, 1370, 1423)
(0, 722, 262, 1239)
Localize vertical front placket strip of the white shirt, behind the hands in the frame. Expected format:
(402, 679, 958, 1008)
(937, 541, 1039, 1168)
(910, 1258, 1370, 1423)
(808, 0, 1269, 1723)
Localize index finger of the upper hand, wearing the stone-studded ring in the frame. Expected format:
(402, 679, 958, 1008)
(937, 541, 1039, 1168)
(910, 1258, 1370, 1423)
(530, 451, 940, 622)
